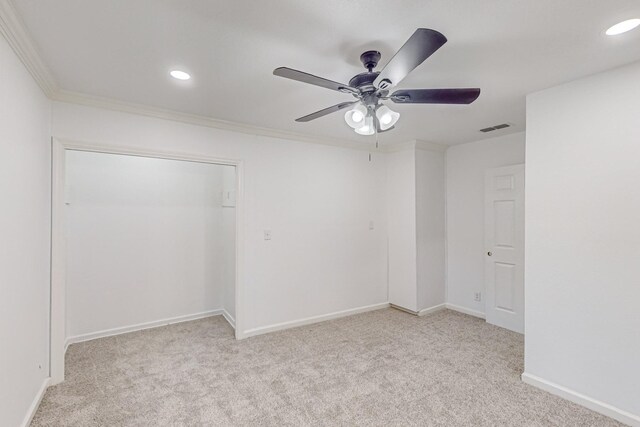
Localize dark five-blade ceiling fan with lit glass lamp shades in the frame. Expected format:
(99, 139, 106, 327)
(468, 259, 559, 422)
(273, 28, 480, 135)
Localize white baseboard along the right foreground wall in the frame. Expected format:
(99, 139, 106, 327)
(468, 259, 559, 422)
(522, 372, 640, 427)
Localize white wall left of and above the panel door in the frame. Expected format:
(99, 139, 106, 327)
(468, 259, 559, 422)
(446, 133, 525, 313)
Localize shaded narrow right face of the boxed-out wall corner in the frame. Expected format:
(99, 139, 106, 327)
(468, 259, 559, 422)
(415, 149, 445, 311)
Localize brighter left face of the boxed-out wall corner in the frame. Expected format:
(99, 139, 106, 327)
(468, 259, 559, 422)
(386, 147, 418, 311)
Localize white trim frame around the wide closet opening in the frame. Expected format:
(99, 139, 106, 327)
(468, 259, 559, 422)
(49, 138, 245, 385)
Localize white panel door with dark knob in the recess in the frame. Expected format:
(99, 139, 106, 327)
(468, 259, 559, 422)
(484, 165, 524, 333)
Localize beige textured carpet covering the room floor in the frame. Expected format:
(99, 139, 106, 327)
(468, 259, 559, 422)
(32, 309, 619, 427)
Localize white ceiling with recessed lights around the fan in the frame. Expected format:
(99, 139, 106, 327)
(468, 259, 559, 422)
(14, 0, 640, 144)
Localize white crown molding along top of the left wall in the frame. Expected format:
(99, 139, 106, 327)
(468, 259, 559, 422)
(0, 0, 58, 98)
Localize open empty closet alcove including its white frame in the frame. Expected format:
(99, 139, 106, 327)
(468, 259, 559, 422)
(50, 141, 242, 384)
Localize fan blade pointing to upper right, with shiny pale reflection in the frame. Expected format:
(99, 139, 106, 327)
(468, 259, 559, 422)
(373, 28, 447, 89)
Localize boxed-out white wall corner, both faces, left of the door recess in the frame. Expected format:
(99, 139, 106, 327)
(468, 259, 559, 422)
(386, 145, 445, 312)
